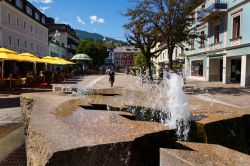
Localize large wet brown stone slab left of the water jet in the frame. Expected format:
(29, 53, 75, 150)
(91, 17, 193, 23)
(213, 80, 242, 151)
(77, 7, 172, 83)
(22, 90, 176, 165)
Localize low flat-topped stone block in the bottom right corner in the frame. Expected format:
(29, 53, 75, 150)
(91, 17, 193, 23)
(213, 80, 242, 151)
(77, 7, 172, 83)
(160, 142, 250, 166)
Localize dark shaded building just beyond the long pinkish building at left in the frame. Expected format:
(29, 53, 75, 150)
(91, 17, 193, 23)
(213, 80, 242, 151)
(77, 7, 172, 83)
(46, 18, 80, 60)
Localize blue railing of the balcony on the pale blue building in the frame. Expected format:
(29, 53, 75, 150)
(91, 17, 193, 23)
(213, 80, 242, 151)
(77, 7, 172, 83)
(197, 0, 227, 21)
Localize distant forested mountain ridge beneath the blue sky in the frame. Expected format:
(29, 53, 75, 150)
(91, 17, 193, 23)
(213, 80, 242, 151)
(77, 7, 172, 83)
(75, 29, 127, 45)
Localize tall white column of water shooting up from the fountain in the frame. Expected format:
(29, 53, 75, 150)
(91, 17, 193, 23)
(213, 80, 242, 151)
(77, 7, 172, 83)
(161, 73, 190, 140)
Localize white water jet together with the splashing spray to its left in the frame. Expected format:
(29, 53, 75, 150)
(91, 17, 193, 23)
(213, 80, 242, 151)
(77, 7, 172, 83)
(121, 73, 190, 140)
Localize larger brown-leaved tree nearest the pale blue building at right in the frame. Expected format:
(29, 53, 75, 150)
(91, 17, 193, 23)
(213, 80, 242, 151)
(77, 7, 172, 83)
(125, 0, 204, 69)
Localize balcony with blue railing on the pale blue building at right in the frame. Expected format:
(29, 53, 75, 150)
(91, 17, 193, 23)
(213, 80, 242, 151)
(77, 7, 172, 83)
(197, 0, 227, 22)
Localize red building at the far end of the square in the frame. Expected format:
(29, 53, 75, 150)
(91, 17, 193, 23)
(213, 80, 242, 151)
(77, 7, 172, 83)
(114, 46, 138, 72)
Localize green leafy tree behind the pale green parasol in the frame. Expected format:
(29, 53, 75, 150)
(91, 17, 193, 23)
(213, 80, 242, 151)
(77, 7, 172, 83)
(77, 40, 108, 68)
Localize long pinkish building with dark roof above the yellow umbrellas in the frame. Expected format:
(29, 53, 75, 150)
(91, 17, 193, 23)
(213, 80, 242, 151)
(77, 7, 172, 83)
(0, 0, 48, 57)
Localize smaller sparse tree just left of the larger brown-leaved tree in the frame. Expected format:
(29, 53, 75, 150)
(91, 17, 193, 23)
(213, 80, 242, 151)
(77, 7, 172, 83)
(124, 6, 164, 80)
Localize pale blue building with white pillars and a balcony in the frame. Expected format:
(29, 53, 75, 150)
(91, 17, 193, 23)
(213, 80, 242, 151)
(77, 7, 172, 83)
(185, 0, 250, 87)
